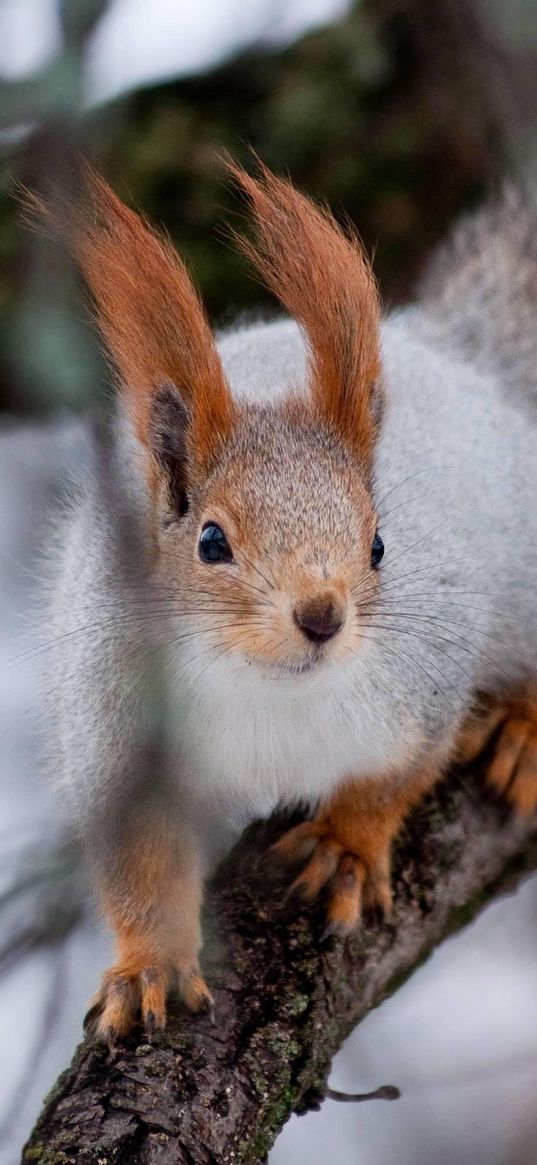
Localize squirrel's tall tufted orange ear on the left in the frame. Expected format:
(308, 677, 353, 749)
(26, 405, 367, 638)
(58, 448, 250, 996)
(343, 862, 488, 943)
(23, 162, 234, 472)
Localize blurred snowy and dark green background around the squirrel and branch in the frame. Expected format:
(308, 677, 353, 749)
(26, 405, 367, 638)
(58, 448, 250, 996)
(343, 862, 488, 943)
(0, 0, 537, 1165)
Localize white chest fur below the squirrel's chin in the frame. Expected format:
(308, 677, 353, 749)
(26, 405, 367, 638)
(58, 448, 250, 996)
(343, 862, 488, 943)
(170, 656, 416, 821)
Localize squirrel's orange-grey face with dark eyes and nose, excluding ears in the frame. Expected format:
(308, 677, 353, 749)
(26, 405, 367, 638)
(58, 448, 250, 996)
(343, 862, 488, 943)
(161, 408, 382, 675)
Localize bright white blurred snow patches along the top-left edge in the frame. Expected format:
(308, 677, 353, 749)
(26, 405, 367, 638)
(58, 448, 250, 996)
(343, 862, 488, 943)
(0, 0, 349, 105)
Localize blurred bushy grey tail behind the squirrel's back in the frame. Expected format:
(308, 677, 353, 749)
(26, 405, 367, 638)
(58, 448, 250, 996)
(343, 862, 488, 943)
(419, 185, 537, 405)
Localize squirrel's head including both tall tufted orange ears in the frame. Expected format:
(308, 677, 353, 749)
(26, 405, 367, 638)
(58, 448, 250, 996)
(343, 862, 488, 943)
(29, 159, 382, 673)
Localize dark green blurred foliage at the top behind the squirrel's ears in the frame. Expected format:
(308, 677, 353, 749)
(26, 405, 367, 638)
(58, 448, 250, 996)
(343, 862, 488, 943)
(0, 0, 524, 411)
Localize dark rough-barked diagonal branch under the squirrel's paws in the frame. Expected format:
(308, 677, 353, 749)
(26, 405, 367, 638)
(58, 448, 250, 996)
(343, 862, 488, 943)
(22, 774, 537, 1165)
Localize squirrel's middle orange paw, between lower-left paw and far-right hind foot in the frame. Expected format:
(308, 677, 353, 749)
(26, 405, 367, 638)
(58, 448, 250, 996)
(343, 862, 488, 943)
(273, 818, 391, 938)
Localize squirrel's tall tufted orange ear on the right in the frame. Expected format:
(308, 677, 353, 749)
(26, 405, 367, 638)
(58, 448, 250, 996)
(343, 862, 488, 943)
(228, 163, 381, 467)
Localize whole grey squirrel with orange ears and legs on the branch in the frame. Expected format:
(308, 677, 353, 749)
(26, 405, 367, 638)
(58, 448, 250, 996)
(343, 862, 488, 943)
(30, 163, 537, 1045)
